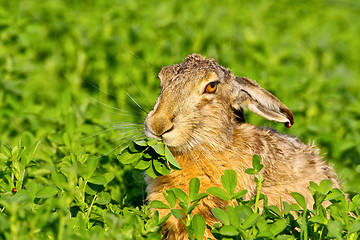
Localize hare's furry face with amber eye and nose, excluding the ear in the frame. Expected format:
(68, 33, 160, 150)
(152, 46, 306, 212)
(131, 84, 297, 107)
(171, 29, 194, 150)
(145, 66, 232, 152)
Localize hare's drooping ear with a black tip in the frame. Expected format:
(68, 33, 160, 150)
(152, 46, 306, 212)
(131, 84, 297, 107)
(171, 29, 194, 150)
(232, 77, 294, 128)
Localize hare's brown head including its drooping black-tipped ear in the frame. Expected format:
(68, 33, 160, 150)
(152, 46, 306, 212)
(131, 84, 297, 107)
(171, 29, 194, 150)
(145, 54, 294, 152)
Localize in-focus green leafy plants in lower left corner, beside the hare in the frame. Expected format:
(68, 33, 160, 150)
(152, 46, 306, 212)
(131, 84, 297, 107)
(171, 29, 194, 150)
(0, 142, 164, 239)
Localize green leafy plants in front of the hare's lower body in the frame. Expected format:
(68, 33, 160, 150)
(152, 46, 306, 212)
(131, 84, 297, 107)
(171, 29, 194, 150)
(150, 159, 360, 239)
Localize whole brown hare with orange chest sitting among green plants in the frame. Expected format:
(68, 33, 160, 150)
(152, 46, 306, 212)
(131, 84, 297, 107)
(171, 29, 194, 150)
(144, 54, 340, 239)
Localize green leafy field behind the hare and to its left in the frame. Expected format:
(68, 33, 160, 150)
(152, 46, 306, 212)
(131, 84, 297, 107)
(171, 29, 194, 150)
(0, 0, 360, 239)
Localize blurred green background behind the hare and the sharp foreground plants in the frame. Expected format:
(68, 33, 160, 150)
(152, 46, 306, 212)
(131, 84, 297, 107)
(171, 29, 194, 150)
(0, 0, 360, 201)
